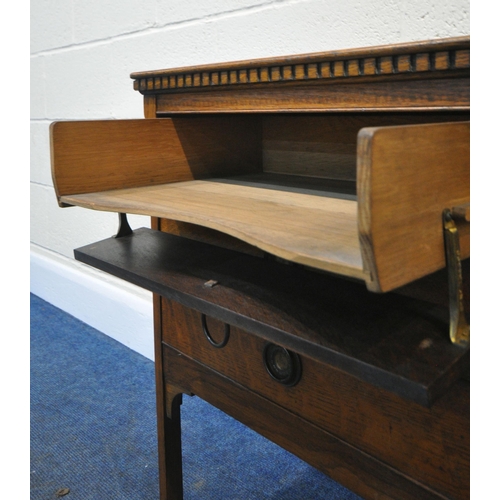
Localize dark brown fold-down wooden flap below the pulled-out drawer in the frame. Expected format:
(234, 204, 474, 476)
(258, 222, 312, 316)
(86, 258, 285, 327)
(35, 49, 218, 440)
(75, 229, 468, 405)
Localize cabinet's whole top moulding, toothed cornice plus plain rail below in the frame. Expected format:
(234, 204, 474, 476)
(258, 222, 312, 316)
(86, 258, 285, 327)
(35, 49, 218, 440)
(141, 37, 470, 116)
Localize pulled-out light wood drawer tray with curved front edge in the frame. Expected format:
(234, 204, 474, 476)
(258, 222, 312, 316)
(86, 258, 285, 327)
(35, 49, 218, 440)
(51, 113, 470, 291)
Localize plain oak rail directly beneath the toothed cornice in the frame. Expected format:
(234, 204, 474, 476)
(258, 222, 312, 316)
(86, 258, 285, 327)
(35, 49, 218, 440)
(157, 75, 470, 116)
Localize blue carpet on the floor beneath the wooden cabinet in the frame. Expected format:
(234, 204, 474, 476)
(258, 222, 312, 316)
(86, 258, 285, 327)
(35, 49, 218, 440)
(31, 295, 359, 500)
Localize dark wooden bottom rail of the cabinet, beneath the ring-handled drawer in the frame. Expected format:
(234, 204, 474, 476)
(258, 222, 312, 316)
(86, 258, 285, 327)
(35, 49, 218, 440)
(162, 344, 446, 500)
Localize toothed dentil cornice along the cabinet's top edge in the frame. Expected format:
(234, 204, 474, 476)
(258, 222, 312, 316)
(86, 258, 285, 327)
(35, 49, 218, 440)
(131, 37, 470, 94)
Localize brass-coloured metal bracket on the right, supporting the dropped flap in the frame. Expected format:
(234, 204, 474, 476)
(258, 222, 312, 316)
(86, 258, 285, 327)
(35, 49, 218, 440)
(443, 207, 470, 346)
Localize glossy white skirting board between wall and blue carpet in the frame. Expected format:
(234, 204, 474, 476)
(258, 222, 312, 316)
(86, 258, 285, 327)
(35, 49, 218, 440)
(30, 244, 154, 360)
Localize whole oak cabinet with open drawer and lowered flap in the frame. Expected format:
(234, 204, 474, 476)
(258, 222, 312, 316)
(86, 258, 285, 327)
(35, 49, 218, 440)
(51, 37, 470, 500)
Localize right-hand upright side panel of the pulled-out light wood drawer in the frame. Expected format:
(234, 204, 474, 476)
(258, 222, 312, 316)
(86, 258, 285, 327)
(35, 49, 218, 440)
(357, 122, 470, 291)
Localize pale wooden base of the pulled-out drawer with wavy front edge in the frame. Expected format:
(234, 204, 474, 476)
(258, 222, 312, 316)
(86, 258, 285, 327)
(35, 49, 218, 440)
(61, 177, 365, 279)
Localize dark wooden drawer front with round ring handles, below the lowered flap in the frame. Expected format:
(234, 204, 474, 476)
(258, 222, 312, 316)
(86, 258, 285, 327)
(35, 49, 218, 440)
(162, 300, 469, 498)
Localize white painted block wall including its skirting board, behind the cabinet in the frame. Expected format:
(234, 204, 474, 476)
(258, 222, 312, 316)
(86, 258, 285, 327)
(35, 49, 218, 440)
(30, 0, 470, 359)
